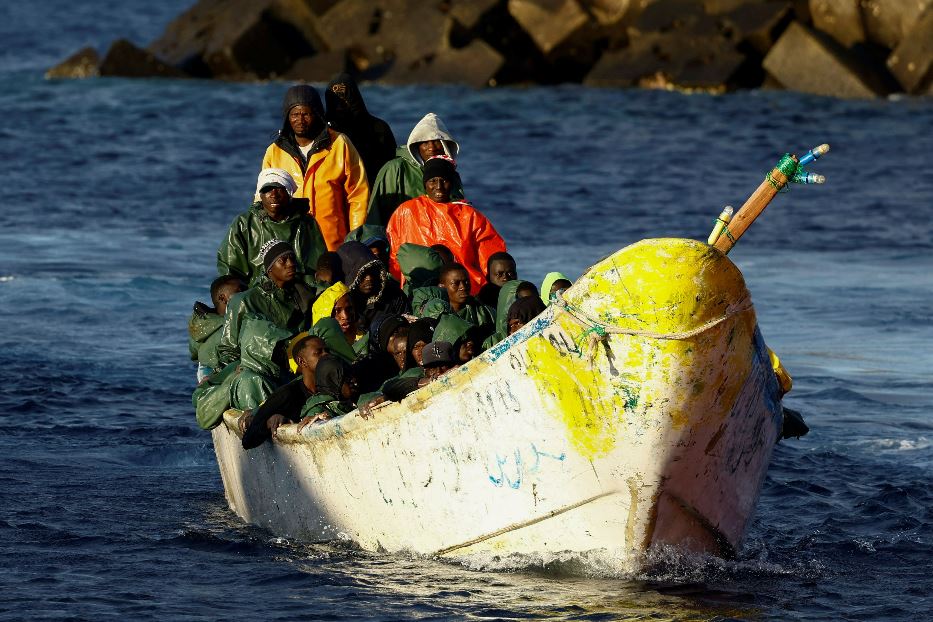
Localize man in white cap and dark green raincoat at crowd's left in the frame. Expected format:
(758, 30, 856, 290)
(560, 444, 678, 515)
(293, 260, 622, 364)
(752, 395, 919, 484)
(217, 168, 327, 286)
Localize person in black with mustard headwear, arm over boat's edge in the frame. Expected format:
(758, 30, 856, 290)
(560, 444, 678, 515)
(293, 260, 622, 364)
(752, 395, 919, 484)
(240, 333, 327, 449)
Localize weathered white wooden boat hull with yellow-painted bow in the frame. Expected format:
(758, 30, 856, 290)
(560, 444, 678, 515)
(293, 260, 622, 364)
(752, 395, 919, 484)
(213, 239, 782, 566)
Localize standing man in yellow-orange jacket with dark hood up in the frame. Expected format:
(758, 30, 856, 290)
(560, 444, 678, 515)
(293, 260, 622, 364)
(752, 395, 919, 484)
(262, 84, 369, 251)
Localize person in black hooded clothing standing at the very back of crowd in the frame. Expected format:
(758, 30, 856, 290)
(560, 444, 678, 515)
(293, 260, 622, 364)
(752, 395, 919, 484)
(324, 73, 396, 187)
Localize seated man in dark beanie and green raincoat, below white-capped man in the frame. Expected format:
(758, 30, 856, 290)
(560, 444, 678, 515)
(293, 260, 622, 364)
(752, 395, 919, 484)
(217, 240, 314, 410)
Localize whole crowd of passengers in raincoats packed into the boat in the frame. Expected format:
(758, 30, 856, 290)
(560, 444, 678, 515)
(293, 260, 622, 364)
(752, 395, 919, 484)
(188, 74, 571, 449)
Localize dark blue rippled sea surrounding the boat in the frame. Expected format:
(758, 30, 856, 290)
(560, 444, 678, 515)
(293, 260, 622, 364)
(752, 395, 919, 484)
(0, 0, 933, 620)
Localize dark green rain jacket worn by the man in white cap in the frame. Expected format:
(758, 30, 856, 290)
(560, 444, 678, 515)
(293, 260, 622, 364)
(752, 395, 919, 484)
(217, 199, 327, 286)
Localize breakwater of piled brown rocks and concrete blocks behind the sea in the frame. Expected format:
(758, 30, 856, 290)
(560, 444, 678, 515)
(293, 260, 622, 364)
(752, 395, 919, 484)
(47, 0, 933, 97)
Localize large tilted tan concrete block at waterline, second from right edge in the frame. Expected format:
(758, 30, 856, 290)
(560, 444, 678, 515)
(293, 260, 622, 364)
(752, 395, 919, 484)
(763, 22, 880, 98)
